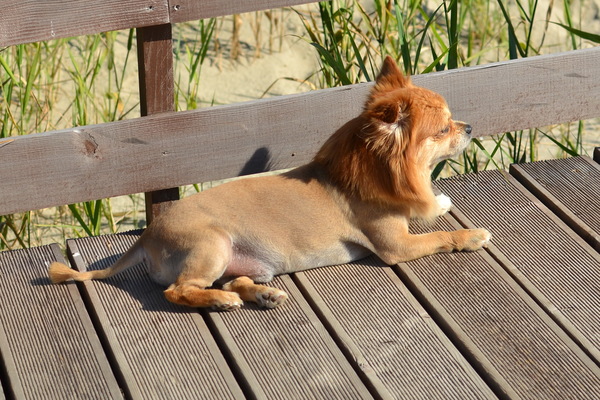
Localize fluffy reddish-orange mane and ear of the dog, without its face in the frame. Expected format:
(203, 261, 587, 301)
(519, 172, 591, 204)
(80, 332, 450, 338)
(314, 57, 437, 219)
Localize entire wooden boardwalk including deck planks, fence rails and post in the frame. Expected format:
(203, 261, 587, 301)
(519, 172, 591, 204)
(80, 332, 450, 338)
(0, 0, 600, 399)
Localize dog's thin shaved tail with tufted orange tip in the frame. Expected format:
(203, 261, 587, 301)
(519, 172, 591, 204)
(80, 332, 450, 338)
(48, 241, 144, 283)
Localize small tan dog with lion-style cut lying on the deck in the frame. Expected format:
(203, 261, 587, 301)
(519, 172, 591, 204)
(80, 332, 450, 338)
(49, 57, 491, 310)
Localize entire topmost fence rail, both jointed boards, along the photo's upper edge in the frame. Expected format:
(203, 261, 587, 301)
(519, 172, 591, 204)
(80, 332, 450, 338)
(0, 0, 315, 47)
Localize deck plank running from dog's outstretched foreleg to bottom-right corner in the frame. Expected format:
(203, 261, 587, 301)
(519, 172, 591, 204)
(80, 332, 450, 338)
(397, 217, 600, 400)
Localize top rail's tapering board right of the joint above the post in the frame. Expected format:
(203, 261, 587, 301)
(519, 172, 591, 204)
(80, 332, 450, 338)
(169, 0, 316, 23)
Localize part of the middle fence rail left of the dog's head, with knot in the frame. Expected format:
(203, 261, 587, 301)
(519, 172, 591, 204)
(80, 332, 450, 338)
(0, 85, 368, 215)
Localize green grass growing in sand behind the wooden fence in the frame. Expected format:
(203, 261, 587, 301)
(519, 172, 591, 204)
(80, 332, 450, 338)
(0, 0, 600, 249)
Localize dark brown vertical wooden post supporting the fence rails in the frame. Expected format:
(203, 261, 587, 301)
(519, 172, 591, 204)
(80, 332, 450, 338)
(137, 24, 179, 224)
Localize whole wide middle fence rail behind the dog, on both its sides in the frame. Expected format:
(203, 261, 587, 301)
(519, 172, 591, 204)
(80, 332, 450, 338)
(0, 48, 600, 215)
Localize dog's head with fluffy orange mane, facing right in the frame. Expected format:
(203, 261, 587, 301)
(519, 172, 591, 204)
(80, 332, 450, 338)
(315, 57, 471, 219)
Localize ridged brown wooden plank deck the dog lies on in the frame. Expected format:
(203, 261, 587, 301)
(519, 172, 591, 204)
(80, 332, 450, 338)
(0, 157, 600, 400)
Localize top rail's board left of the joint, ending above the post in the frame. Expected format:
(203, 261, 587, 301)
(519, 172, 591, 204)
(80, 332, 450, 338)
(0, 0, 169, 47)
